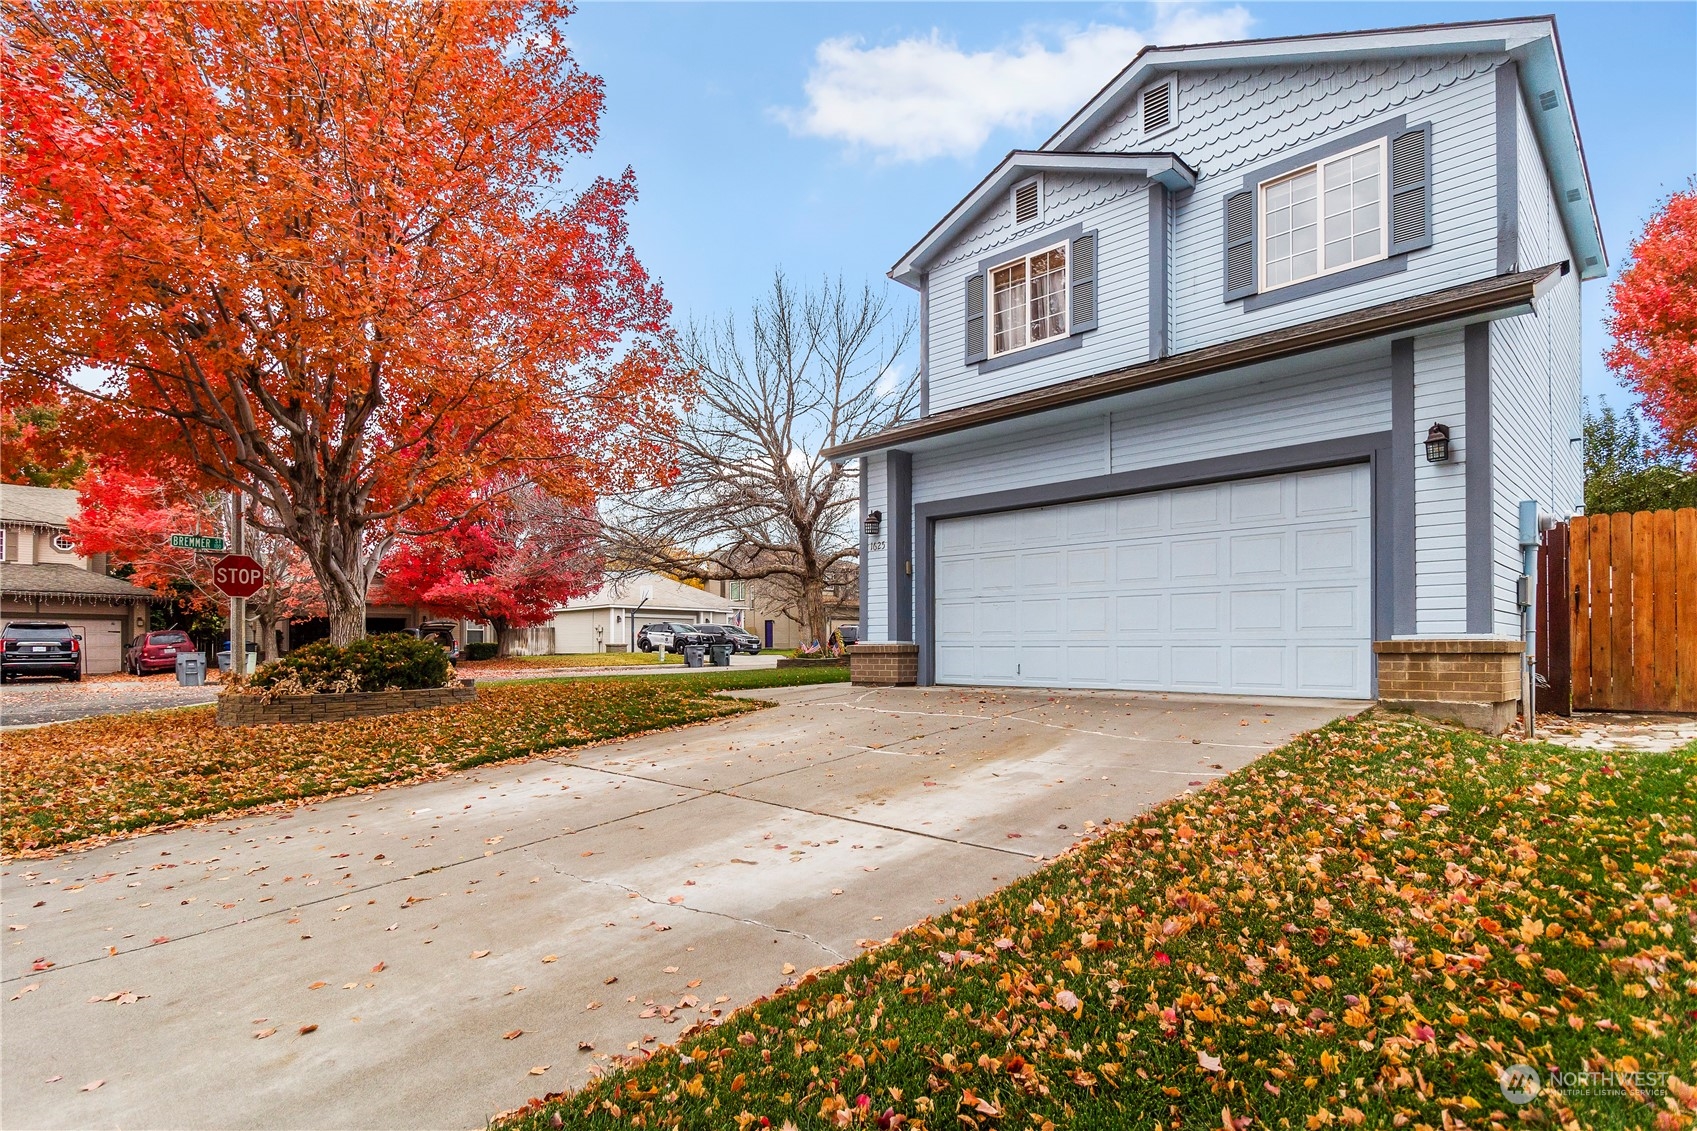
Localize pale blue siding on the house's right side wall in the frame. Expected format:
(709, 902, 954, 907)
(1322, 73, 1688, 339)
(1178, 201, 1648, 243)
(1490, 84, 1585, 635)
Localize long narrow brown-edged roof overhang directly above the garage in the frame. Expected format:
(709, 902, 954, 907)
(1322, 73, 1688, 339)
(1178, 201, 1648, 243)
(823, 263, 1566, 460)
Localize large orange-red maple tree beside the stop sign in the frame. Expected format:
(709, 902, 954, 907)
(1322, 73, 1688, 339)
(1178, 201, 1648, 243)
(0, 0, 687, 642)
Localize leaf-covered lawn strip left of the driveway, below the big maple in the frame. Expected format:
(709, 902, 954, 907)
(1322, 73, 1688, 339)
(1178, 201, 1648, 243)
(0, 671, 847, 854)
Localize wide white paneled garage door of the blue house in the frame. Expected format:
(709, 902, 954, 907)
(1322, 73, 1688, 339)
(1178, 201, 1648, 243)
(933, 464, 1373, 698)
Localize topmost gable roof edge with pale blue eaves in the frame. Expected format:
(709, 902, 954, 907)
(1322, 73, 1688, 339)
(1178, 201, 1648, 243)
(1042, 15, 1609, 279)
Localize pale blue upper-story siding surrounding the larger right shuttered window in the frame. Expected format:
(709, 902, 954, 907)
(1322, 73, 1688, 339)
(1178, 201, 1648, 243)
(1086, 56, 1500, 353)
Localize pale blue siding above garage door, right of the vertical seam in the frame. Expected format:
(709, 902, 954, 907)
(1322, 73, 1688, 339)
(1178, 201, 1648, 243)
(1113, 350, 1390, 472)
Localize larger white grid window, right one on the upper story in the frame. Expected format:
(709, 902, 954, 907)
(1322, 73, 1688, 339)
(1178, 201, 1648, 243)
(1261, 141, 1386, 290)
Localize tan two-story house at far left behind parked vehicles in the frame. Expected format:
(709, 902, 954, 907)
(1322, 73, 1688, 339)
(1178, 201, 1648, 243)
(0, 482, 158, 674)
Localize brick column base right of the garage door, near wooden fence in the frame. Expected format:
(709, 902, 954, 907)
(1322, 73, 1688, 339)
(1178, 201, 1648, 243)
(1373, 637, 1526, 734)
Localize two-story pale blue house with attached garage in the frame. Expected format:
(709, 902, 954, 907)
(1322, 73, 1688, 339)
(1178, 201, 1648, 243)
(828, 17, 1607, 717)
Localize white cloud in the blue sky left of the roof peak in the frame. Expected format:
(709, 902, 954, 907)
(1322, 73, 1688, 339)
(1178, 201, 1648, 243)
(776, 5, 1251, 161)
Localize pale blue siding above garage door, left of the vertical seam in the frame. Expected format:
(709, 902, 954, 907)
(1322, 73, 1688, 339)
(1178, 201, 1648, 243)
(913, 416, 1108, 503)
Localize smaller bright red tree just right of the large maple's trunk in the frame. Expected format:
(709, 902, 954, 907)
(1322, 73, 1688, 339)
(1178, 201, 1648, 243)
(380, 487, 601, 654)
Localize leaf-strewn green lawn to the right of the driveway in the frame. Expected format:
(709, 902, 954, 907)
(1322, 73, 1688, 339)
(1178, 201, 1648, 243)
(504, 715, 1697, 1131)
